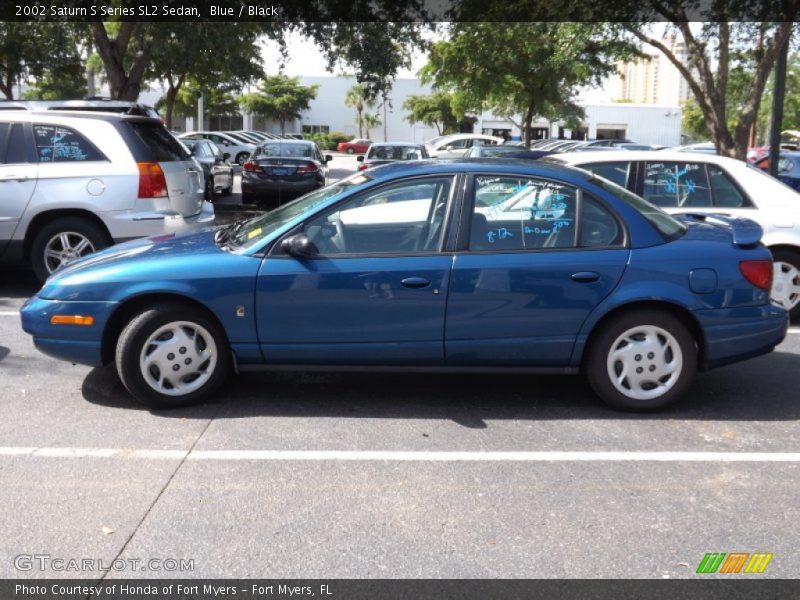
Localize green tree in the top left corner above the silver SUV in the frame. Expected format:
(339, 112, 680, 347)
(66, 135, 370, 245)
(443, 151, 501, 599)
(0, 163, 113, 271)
(0, 21, 86, 100)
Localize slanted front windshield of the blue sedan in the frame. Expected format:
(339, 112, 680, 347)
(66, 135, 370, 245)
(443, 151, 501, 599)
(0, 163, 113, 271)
(229, 173, 372, 248)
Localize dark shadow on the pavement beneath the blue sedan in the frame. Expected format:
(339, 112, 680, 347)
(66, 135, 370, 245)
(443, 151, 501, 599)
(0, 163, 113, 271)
(82, 352, 800, 429)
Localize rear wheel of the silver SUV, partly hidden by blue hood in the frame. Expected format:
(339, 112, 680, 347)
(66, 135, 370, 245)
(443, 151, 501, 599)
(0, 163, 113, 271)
(31, 217, 111, 281)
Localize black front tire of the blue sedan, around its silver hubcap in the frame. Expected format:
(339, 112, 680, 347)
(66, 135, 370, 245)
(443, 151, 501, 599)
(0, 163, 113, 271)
(115, 302, 231, 409)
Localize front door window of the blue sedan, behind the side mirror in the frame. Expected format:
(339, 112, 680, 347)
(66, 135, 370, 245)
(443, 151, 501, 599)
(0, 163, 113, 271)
(305, 177, 453, 256)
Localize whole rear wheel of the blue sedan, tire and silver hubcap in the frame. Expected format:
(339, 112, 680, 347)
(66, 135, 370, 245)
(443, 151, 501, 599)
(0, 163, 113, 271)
(585, 309, 697, 412)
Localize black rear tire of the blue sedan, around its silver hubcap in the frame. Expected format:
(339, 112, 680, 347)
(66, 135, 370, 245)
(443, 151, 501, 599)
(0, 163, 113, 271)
(584, 309, 697, 412)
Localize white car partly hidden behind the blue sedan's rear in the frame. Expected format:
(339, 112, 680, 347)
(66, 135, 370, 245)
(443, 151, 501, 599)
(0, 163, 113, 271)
(545, 150, 800, 319)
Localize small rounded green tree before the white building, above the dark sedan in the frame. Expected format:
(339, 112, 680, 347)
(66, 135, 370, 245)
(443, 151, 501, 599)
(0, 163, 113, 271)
(240, 75, 319, 135)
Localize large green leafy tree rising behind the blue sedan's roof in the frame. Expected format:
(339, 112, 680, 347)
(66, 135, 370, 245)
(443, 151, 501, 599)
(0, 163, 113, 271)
(421, 22, 633, 143)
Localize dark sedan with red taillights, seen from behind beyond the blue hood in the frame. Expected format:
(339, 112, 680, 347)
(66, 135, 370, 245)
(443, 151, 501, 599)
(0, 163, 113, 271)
(242, 139, 331, 208)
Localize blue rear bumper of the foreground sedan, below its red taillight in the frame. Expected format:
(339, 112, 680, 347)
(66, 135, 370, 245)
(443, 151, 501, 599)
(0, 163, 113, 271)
(694, 305, 789, 369)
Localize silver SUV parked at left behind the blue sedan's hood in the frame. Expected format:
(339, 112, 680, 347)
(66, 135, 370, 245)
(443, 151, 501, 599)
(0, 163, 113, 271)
(0, 110, 214, 280)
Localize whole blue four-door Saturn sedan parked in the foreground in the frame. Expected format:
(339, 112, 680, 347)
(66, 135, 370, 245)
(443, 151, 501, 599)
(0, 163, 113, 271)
(22, 159, 788, 411)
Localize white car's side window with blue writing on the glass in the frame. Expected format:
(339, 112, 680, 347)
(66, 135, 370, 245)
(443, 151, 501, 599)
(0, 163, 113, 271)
(642, 161, 711, 208)
